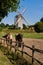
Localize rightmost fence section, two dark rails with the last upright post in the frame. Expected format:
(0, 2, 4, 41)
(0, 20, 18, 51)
(24, 45, 43, 65)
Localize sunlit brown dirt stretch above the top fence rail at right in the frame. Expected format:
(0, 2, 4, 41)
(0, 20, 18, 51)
(23, 38, 43, 50)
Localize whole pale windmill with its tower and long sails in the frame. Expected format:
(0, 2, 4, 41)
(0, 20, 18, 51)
(14, 9, 29, 29)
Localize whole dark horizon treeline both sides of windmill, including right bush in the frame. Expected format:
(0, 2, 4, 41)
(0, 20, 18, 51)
(0, 17, 43, 33)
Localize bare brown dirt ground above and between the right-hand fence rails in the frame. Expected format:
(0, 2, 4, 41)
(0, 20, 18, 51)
(12, 38, 43, 62)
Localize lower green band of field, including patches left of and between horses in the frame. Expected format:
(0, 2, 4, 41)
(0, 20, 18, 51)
(0, 32, 43, 39)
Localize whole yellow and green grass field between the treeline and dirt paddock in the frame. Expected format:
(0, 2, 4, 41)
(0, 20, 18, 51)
(0, 30, 43, 39)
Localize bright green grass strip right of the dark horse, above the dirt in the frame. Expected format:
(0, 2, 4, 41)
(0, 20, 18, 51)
(23, 33, 43, 39)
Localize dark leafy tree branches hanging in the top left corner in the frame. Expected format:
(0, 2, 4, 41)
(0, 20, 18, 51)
(0, 0, 20, 21)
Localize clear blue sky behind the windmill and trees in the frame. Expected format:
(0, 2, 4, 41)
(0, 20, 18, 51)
(1, 0, 43, 25)
